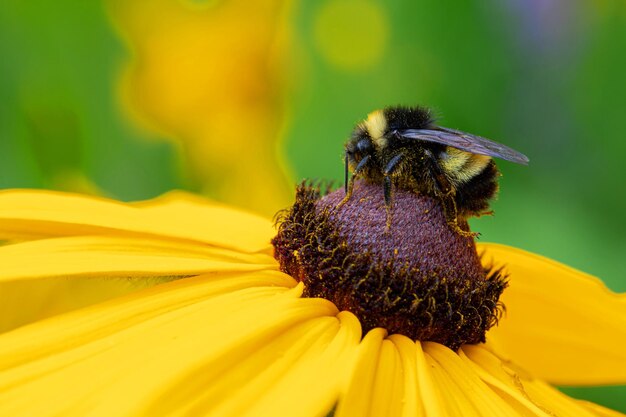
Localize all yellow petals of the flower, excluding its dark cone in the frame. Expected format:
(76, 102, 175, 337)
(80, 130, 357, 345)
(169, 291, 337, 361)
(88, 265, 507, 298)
(0, 190, 626, 416)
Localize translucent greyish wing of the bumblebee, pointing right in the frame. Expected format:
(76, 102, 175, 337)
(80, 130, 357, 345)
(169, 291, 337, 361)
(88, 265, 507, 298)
(396, 126, 528, 165)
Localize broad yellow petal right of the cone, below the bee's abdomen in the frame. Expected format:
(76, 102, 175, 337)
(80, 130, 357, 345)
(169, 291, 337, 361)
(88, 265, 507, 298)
(479, 244, 626, 385)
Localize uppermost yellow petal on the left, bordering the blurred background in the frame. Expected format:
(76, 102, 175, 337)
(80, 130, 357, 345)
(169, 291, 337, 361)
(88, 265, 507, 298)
(0, 190, 274, 252)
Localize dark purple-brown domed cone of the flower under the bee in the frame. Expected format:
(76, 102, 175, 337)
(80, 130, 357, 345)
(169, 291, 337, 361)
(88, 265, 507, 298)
(272, 182, 506, 349)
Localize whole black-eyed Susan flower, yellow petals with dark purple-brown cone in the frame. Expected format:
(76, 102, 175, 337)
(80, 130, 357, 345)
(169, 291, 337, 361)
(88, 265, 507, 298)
(0, 186, 626, 417)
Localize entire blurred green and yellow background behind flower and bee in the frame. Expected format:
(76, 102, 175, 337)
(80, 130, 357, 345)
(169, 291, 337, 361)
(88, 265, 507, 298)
(0, 0, 626, 411)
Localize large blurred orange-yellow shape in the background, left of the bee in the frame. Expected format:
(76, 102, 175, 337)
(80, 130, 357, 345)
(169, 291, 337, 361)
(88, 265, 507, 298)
(108, 0, 293, 215)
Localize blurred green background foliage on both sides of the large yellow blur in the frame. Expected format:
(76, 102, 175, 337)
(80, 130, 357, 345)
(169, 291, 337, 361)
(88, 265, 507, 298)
(0, 0, 626, 411)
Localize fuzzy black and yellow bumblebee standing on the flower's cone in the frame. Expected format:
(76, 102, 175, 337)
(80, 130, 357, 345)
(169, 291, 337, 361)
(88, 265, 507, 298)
(340, 107, 528, 236)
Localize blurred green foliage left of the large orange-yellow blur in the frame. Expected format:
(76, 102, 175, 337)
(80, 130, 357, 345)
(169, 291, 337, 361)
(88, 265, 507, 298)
(0, 0, 182, 199)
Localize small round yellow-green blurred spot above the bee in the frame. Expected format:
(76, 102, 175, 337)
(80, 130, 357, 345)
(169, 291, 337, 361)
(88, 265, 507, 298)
(315, 0, 389, 71)
